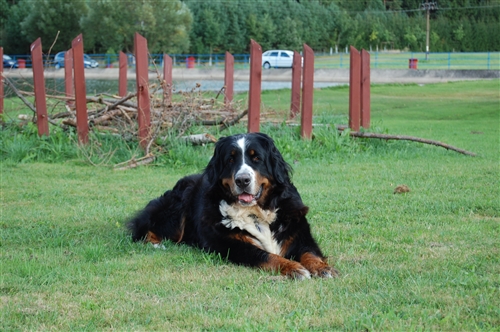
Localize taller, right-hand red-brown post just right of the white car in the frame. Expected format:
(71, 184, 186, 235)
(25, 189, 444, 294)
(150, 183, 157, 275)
(300, 44, 314, 139)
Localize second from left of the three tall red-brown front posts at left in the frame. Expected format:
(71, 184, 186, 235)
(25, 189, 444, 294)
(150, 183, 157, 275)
(71, 34, 89, 144)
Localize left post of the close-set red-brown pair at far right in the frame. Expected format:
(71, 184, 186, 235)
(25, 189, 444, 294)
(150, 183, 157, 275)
(349, 46, 361, 131)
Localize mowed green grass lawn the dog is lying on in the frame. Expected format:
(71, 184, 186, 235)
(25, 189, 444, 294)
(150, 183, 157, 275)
(0, 80, 500, 331)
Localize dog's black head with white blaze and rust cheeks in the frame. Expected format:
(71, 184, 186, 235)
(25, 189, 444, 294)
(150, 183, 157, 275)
(205, 133, 291, 206)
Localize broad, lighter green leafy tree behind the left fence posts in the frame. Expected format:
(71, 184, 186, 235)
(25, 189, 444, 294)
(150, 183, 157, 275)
(82, 0, 192, 53)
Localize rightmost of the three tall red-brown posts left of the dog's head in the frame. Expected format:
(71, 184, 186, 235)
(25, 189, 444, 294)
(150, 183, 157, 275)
(134, 32, 151, 149)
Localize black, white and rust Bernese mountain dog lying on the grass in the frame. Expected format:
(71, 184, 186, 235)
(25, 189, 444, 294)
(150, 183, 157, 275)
(127, 133, 338, 279)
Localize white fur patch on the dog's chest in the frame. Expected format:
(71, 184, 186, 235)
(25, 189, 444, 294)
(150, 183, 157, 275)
(219, 200, 281, 255)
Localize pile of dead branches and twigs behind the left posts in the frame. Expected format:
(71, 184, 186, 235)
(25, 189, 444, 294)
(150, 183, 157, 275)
(5, 78, 247, 144)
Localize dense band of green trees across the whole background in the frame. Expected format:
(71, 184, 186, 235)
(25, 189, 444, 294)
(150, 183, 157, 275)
(0, 0, 500, 54)
